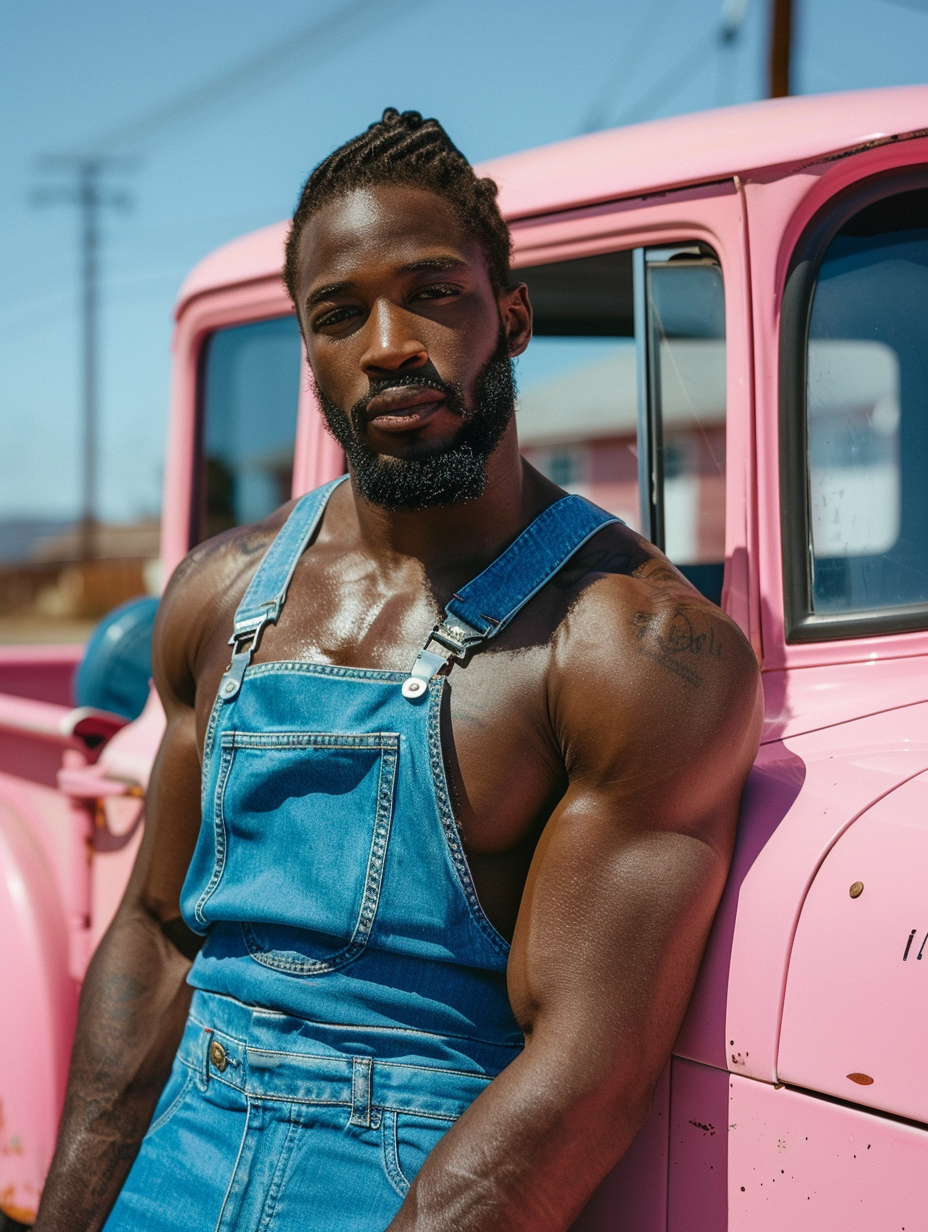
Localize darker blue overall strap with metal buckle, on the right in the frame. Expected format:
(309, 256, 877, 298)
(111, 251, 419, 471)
(403, 496, 621, 701)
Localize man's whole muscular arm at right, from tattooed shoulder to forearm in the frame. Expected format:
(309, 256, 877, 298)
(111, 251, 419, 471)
(391, 569, 762, 1232)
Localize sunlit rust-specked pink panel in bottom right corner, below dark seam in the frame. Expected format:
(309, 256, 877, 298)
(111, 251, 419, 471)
(729, 1076, 928, 1232)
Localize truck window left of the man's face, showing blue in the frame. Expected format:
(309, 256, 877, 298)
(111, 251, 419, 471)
(192, 317, 301, 543)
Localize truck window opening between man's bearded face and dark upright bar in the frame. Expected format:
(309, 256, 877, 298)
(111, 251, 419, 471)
(515, 253, 640, 530)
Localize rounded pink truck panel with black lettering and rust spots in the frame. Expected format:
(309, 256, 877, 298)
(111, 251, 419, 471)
(776, 775, 928, 1124)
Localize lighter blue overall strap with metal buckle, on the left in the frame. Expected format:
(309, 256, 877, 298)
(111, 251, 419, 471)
(219, 474, 348, 701)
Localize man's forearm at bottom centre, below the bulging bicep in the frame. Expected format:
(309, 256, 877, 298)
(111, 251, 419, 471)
(389, 1047, 649, 1232)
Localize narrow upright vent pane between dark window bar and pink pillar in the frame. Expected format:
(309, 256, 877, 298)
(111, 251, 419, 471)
(635, 244, 726, 602)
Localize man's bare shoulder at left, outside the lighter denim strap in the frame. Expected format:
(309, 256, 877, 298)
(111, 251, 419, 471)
(152, 501, 293, 706)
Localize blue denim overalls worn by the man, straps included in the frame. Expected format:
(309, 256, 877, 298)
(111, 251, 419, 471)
(106, 480, 616, 1232)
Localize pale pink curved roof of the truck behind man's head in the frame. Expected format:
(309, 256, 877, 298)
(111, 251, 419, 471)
(176, 86, 928, 315)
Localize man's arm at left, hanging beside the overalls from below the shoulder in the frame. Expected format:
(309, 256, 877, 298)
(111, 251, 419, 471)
(36, 561, 211, 1232)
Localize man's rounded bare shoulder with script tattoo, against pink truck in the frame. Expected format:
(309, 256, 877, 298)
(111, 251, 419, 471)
(551, 527, 762, 822)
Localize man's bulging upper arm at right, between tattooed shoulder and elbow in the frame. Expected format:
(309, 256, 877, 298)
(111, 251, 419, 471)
(509, 791, 728, 1089)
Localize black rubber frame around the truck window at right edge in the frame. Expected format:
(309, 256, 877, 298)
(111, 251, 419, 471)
(779, 165, 928, 644)
